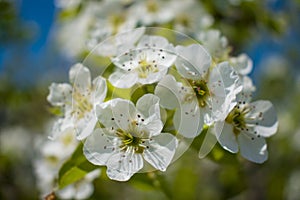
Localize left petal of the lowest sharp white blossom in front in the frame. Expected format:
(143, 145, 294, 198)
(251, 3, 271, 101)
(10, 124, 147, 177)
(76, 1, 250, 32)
(83, 129, 116, 165)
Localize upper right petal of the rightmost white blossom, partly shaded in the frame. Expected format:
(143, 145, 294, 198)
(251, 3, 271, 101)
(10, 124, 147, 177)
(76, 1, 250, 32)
(246, 100, 278, 137)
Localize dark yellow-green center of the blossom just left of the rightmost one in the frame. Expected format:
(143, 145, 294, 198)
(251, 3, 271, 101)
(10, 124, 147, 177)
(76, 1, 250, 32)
(189, 80, 209, 107)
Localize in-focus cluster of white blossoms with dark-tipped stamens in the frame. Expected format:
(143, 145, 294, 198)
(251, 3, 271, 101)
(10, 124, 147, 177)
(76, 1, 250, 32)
(47, 29, 277, 187)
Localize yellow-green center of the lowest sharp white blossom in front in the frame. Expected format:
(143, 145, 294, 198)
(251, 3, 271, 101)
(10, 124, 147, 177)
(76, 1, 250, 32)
(117, 129, 145, 153)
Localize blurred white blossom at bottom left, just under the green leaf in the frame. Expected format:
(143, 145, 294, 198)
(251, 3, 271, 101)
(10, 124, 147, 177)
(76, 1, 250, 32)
(57, 169, 101, 199)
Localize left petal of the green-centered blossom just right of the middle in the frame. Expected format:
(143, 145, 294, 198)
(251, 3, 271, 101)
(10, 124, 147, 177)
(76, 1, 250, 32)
(154, 74, 180, 109)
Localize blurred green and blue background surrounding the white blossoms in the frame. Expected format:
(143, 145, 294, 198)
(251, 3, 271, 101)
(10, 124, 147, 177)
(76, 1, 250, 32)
(0, 0, 300, 200)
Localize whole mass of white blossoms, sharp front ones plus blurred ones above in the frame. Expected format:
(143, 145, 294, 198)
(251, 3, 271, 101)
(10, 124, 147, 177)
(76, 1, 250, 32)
(35, 0, 278, 197)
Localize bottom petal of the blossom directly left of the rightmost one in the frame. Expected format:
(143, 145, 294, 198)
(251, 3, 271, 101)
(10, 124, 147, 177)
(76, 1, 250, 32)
(173, 102, 203, 138)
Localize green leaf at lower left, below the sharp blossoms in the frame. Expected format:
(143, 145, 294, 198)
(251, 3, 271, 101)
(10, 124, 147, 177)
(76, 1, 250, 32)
(58, 143, 98, 189)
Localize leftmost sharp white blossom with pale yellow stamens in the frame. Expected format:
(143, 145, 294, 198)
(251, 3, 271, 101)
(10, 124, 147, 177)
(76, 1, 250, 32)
(47, 63, 107, 140)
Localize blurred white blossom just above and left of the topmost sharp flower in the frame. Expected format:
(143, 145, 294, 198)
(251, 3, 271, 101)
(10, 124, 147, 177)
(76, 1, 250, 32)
(87, 0, 140, 56)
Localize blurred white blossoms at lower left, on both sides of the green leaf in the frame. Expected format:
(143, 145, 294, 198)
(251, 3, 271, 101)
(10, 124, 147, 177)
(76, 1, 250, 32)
(34, 122, 100, 199)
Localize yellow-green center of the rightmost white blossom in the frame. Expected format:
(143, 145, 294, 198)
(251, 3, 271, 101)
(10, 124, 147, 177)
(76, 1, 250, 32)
(225, 107, 249, 135)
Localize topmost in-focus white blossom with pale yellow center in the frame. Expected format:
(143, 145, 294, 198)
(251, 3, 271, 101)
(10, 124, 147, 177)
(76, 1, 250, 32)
(109, 35, 176, 88)
